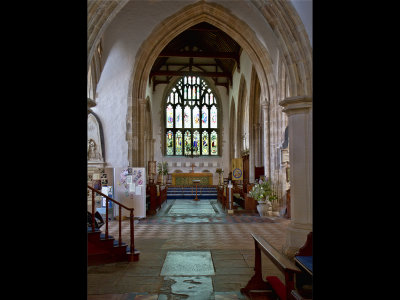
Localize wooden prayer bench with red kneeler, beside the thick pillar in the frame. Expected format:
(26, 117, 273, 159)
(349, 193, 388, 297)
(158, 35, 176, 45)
(240, 233, 301, 300)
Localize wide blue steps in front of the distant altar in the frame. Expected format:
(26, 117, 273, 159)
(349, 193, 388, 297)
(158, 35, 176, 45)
(167, 186, 218, 200)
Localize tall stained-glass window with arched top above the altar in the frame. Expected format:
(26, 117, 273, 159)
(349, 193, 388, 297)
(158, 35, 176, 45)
(165, 76, 219, 156)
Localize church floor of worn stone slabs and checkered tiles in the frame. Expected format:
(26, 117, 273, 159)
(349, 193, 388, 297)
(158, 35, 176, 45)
(87, 199, 290, 300)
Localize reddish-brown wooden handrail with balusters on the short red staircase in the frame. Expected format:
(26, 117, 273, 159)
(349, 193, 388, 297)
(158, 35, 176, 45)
(88, 185, 135, 258)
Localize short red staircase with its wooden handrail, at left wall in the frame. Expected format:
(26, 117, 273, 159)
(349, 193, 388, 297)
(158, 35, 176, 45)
(87, 186, 140, 266)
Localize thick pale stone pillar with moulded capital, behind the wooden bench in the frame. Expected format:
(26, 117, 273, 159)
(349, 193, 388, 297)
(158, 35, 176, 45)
(279, 96, 312, 257)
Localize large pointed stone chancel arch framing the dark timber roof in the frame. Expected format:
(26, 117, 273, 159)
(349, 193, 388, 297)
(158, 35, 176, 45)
(127, 2, 275, 165)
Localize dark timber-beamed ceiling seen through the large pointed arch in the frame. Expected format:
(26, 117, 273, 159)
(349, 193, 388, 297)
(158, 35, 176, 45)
(150, 22, 241, 91)
